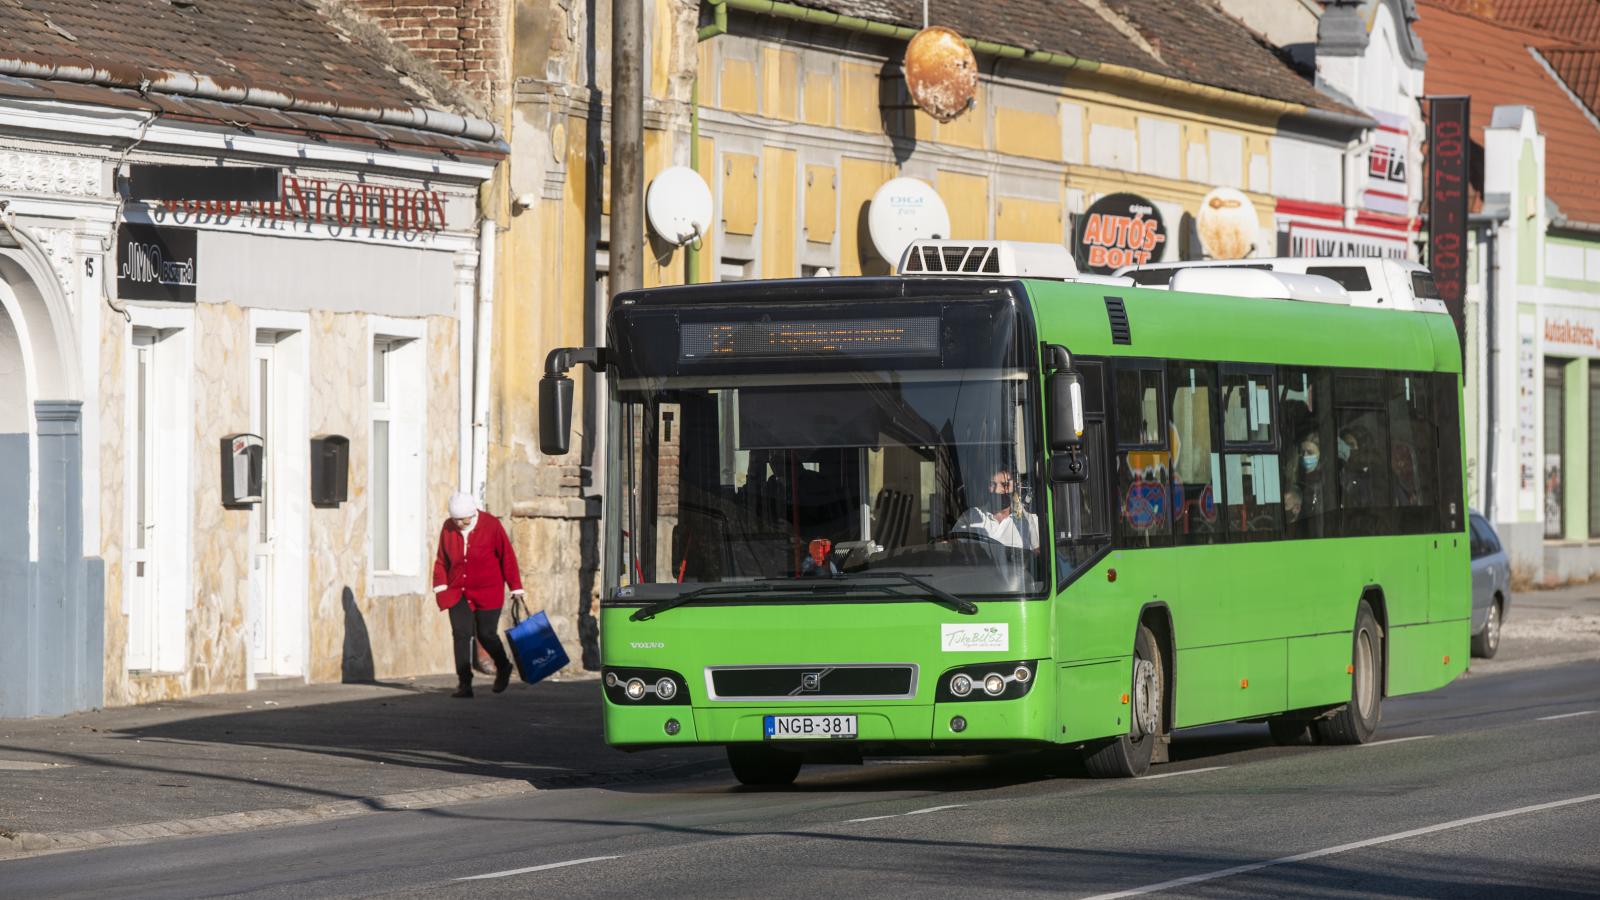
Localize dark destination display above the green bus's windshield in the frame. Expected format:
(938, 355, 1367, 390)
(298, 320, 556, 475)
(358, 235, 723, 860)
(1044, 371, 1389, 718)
(678, 315, 939, 362)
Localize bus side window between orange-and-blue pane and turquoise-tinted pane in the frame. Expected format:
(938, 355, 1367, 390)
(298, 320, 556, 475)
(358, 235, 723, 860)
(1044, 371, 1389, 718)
(1168, 362, 1222, 544)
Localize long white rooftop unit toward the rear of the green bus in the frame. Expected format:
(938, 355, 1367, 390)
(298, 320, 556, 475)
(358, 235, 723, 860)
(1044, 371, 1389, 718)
(1117, 256, 1445, 312)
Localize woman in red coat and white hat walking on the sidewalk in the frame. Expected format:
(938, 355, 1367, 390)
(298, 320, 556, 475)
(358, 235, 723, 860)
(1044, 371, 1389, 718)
(434, 492, 523, 697)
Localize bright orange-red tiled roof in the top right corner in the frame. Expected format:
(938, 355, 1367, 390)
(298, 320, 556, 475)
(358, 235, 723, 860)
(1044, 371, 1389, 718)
(1416, 0, 1600, 224)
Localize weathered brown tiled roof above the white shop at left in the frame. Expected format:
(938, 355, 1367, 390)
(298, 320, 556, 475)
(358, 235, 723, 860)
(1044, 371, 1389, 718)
(0, 0, 502, 152)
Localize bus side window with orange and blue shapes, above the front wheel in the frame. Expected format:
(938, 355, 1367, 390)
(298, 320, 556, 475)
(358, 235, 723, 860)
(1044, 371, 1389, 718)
(1117, 365, 1173, 548)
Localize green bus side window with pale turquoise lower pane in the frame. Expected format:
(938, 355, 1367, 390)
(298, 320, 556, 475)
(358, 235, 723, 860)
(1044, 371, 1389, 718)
(1222, 370, 1283, 541)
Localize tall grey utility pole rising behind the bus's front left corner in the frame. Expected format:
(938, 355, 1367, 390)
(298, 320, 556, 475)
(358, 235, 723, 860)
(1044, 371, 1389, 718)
(608, 0, 645, 296)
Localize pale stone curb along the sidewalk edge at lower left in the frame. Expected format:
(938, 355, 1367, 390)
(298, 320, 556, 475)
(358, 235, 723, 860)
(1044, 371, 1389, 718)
(0, 780, 538, 860)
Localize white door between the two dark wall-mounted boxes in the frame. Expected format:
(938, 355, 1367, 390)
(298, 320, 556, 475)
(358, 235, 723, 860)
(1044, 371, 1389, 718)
(250, 338, 276, 674)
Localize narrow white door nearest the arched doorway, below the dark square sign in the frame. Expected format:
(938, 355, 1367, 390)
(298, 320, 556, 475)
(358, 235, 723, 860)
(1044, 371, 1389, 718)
(126, 331, 160, 669)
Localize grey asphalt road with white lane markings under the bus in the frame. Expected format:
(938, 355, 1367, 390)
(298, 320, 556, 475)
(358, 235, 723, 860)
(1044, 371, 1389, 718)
(0, 661, 1600, 900)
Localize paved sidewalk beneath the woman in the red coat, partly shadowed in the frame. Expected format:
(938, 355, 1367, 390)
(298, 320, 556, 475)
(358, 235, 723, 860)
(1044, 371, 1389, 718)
(0, 676, 725, 860)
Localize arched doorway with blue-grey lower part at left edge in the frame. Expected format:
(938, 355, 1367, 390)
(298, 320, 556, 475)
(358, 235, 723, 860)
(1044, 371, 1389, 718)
(0, 237, 104, 717)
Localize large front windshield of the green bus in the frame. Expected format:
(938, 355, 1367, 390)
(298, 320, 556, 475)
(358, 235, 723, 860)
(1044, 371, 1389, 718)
(606, 368, 1050, 602)
